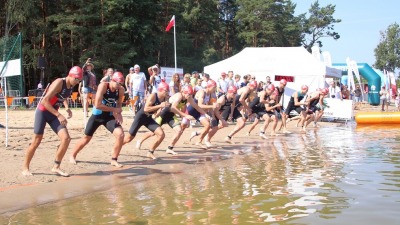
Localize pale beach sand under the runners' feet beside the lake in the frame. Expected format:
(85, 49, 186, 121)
(0, 103, 390, 214)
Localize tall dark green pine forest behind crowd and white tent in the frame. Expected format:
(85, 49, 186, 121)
(0, 0, 340, 93)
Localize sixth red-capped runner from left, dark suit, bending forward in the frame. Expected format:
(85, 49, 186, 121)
(204, 86, 237, 148)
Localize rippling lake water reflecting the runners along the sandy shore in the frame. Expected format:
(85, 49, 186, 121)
(0, 125, 400, 225)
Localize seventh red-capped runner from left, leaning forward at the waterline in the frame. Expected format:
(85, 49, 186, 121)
(225, 80, 258, 144)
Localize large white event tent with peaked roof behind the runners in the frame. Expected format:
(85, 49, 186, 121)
(204, 47, 342, 106)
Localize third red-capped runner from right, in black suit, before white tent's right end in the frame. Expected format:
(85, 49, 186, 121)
(284, 85, 308, 130)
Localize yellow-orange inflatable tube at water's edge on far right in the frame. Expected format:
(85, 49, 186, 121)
(355, 112, 400, 124)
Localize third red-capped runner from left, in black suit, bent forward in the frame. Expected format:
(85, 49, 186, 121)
(124, 82, 171, 159)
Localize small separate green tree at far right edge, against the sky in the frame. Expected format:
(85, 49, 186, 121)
(374, 23, 400, 71)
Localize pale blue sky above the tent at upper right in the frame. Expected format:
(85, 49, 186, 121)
(292, 0, 400, 66)
